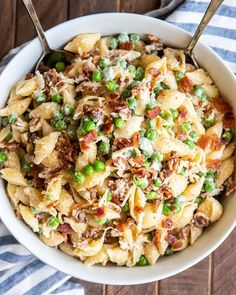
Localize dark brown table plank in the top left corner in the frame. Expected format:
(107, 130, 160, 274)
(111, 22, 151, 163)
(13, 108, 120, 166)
(0, 0, 16, 59)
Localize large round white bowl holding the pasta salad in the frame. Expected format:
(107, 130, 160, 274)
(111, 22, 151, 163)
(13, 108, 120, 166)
(0, 13, 236, 285)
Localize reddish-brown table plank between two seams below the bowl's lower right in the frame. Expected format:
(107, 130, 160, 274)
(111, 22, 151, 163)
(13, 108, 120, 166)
(159, 257, 210, 295)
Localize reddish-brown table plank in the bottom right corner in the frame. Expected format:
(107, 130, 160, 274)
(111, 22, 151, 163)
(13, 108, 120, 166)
(212, 230, 236, 295)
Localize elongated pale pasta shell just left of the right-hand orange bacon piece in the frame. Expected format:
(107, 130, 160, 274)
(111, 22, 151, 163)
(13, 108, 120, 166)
(154, 138, 194, 157)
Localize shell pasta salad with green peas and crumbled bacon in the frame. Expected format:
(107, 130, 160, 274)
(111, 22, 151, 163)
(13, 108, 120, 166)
(0, 33, 235, 267)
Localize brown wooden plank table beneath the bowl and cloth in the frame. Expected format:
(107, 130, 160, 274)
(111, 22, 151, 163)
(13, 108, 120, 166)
(0, 0, 236, 295)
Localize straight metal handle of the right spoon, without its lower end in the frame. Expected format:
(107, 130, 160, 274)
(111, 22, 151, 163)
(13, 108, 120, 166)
(185, 0, 224, 55)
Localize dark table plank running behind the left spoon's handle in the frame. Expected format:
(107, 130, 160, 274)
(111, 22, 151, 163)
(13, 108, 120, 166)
(15, 0, 68, 45)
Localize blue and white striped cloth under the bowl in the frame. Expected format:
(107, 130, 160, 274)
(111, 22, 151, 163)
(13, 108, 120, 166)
(0, 0, 236, 295)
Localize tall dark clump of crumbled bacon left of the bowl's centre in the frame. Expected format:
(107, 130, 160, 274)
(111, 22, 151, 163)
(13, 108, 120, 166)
(55, 133, 76, 170)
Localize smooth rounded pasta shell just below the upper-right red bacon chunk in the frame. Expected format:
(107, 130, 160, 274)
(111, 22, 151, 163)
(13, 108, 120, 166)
(158, 89, 185, 110)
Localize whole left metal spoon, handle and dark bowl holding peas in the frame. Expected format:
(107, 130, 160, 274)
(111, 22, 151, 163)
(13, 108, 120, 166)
(22, 0, 74, 73)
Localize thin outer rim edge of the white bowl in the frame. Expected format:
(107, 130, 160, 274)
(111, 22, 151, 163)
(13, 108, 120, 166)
(0, 12, 236, 285)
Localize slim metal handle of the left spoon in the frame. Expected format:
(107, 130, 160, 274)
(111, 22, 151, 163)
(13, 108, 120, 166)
(22, 0, 51, 54)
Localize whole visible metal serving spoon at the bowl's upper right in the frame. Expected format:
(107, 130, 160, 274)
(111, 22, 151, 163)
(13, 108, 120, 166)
(184, 0, 224, 68)
